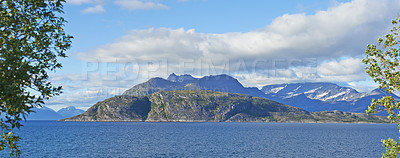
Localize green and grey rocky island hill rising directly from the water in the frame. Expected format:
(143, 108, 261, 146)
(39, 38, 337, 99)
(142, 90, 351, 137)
(61, 90, 387, 122)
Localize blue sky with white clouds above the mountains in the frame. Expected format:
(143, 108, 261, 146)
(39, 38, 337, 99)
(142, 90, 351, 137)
(46, 0, 400, 110)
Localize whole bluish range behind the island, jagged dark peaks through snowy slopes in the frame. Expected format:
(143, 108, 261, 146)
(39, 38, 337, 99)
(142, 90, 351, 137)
(123, 73, 399, 113)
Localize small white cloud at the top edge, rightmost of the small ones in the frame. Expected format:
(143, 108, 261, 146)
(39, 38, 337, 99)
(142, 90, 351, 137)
(114, 0, 168, 11)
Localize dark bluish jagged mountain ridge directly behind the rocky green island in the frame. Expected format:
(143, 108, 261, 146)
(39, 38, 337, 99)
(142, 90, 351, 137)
(123, 73, 266, 97)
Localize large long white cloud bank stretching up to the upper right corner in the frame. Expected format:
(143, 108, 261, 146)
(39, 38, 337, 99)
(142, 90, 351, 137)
(81, 0, 400, 63)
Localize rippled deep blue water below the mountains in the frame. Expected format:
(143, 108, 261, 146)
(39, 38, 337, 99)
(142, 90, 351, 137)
(0, 121, 399, 158)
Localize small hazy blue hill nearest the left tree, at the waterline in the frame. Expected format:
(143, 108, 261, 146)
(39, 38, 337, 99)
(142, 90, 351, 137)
(27, 106, 65, 120)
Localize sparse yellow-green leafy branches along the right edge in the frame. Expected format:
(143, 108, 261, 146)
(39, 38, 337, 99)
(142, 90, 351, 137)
(363, 18, 400, 157)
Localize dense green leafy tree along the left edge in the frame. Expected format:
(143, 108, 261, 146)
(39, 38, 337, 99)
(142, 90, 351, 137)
(0, 0, 72, 156)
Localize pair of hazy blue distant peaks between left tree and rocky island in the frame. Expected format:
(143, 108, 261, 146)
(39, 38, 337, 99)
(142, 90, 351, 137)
(27, 106, 85, 120)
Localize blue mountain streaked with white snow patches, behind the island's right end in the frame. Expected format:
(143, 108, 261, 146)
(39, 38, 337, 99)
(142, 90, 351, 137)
(261, 82, 399, 113)
